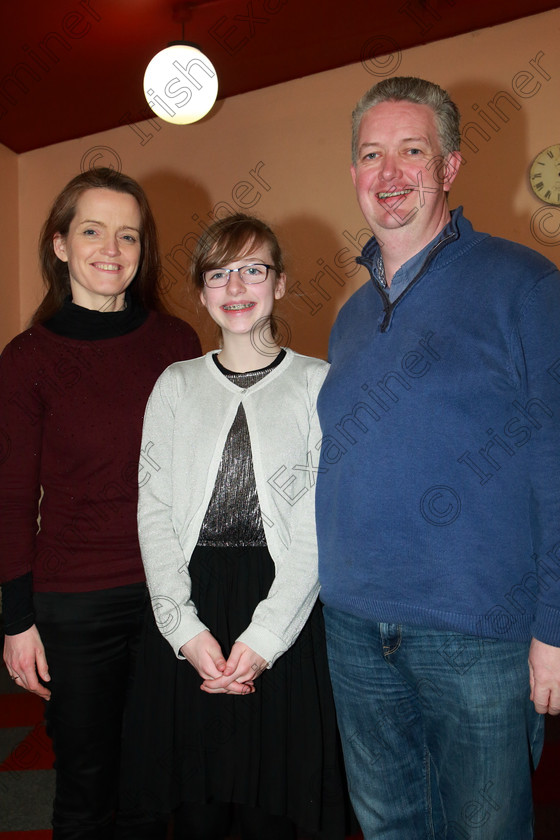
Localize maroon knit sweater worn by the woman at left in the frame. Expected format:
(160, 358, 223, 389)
(0, 312, 200, 592)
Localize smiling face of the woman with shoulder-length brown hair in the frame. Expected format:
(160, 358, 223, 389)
(53, 189, 142, 311)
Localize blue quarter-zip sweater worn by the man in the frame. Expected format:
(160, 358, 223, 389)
(316, 209, 560, 645)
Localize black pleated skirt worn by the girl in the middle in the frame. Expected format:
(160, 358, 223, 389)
(123, 546, 348, 840)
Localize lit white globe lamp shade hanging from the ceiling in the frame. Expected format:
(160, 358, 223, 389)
(144, 41, 218, 125)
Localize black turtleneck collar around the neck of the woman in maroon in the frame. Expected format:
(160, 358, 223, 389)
(43, 292, 148, 341)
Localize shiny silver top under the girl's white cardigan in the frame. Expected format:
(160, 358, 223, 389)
(198, 351, 285, 546)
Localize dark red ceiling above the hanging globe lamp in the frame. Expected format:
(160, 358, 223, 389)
(0, 0, 557, 152)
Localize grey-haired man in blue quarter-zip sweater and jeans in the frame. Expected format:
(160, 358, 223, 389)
(317, 77, 560, 840)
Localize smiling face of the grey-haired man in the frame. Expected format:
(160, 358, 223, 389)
(352, 101, 460, 247)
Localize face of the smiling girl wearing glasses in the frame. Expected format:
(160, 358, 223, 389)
(200, 244, 286, 341)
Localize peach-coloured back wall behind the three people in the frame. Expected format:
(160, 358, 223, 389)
(5, 10, 560, 356)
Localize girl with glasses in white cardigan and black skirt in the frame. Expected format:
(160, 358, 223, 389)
(124, 214, 345, 840)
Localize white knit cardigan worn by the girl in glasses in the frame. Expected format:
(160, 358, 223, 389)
(138, 349, 328, 667)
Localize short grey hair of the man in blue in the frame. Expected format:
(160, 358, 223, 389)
(352, 76, 461, 166)
